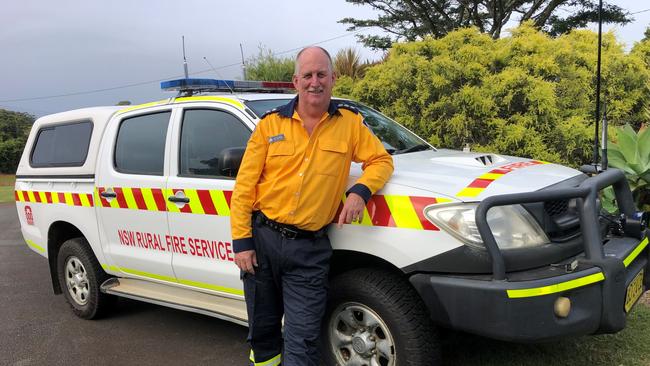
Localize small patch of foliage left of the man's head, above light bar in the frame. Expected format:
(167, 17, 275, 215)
(245, 46, 294, 81)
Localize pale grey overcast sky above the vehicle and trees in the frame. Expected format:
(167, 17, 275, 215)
(0, 0, 650, 116)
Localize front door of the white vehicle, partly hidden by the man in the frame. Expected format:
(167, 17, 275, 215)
(167, 103, 254, 298)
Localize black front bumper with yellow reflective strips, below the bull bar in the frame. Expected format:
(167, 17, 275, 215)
(410, 237, 650, 342)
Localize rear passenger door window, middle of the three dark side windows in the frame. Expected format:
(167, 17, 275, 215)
(115, 112, 171, 175)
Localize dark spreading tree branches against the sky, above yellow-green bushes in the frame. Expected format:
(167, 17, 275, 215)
(339, 0, 632, 49)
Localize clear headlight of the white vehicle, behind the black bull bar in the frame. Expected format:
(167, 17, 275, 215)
(424, 203, 549, 249)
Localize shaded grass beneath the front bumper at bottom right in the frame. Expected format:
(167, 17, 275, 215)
(442, 295, 650, 366)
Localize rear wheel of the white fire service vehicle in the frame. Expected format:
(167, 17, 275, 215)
(57, 238, 115, 319)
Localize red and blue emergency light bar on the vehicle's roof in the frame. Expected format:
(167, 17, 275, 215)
(160, 79, 295, 93)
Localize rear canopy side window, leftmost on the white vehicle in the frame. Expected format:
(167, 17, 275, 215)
(30, 121, 93, 167)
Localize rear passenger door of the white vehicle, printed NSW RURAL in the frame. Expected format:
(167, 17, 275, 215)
(96, 106, 175, 282)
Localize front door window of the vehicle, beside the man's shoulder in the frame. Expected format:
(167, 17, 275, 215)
(180, 109, 251, 176)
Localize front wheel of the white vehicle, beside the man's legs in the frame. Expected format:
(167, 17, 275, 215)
(321, 269, 440, 366)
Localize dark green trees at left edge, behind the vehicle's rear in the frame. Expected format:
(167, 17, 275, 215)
(0, 109, 34, 174)
